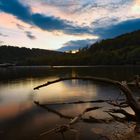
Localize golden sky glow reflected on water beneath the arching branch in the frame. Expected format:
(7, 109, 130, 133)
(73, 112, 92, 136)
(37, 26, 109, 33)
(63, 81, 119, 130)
(36, 80, 97, 103)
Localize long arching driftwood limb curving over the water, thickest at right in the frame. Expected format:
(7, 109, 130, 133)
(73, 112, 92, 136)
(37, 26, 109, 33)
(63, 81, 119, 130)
(34, 77, 140, 120)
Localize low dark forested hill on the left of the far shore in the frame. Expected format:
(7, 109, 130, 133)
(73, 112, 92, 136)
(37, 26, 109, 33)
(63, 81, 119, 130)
(0, 45, 63, 65)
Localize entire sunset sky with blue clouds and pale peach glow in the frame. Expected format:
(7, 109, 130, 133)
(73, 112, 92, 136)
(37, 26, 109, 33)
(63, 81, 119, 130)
(0, 0, 140, 49)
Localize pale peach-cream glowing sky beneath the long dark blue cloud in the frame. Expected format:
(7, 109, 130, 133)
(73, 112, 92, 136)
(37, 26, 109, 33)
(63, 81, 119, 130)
(0, 13, 98, 49)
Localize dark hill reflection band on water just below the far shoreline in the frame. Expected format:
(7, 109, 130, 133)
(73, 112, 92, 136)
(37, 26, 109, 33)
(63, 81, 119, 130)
(0, 66, 140, 82)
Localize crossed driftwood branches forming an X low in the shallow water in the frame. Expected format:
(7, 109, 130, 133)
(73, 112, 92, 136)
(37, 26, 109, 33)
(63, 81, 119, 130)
(34, 101, 112, 140)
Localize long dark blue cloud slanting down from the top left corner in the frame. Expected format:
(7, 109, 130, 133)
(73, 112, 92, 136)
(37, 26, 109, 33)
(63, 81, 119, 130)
(0, 0, 92, 34)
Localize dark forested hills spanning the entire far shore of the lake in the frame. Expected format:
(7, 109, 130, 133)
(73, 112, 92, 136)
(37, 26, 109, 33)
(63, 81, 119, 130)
(0, 30, 140, 65)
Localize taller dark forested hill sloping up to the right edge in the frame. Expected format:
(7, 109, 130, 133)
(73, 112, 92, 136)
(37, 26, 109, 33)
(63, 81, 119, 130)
(81, 30, 140, 65)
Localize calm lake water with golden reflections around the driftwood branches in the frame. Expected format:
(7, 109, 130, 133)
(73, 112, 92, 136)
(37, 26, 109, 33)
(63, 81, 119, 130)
(0, 66, 140, 140)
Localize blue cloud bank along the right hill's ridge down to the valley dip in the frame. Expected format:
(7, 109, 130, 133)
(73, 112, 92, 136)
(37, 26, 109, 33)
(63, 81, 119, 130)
(59, 19, 140, 51)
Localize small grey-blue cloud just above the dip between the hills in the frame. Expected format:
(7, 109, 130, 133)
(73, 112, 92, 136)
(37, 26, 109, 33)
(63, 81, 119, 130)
(58, 39, 96, 51)
